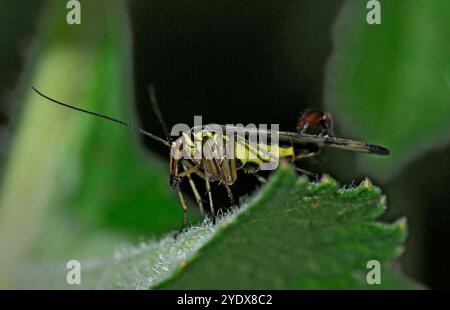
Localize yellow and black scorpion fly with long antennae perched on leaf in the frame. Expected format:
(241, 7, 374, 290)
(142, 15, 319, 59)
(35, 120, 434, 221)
(33, 86, 389, 228)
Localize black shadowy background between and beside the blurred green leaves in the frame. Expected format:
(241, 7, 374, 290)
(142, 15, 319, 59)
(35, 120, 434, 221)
(0, 0, 450, 288)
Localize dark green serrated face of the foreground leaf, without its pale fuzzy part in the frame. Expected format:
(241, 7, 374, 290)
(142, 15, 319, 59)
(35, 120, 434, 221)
(162, 167, 411, 289)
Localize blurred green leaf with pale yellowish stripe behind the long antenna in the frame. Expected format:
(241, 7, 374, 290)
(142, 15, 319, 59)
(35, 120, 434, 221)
(0, 0, 181, 287)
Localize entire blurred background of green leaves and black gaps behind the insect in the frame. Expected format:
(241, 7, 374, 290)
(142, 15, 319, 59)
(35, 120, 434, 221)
(0, 0, 450, 288)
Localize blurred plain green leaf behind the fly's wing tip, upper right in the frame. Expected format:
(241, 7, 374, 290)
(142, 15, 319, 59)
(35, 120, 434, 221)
(325, 0, 450, 177)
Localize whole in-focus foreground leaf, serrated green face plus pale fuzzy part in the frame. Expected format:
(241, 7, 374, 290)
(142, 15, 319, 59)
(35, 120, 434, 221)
(36, 165, 418, 289)
